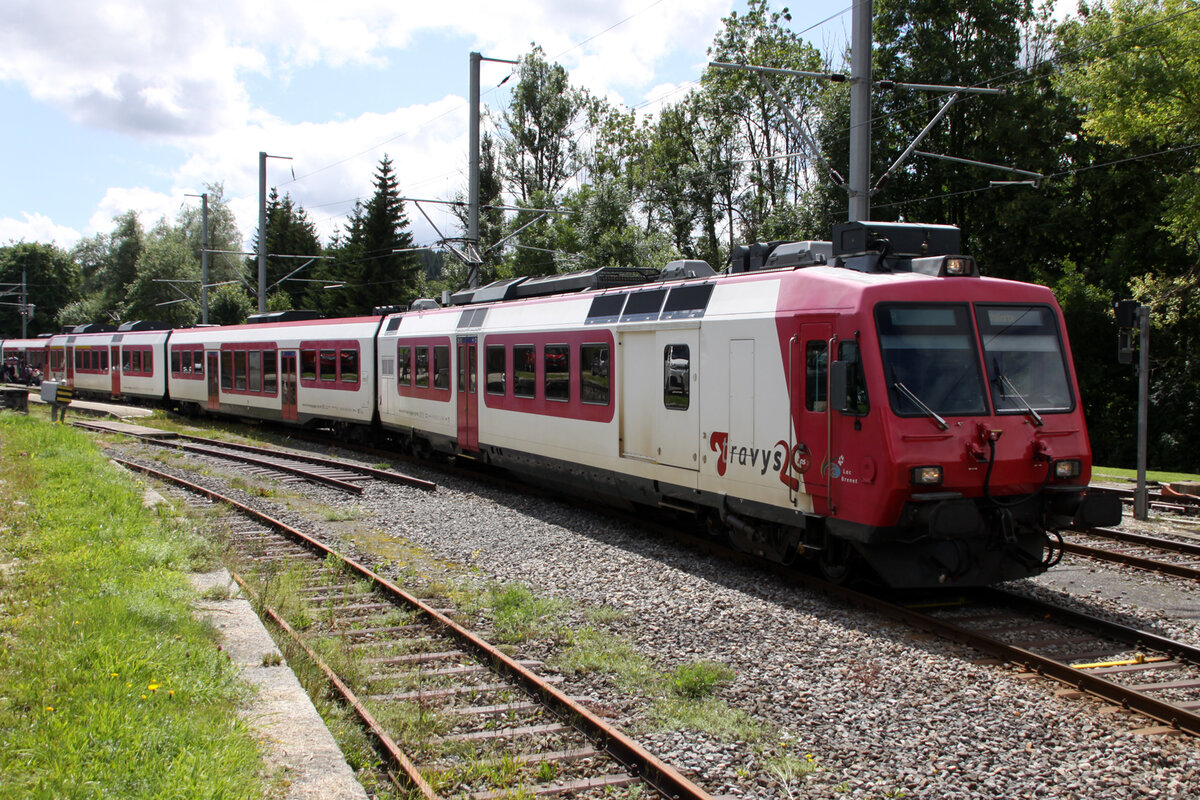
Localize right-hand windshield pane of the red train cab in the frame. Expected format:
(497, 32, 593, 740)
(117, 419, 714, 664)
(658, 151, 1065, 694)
(976, 306, 1074, 414)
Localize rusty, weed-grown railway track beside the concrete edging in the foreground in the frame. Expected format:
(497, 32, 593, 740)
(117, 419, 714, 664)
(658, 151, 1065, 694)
(115, 459, 709, 800)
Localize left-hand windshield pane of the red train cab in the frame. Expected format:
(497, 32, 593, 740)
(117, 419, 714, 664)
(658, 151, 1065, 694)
(875, 303, 988, 416)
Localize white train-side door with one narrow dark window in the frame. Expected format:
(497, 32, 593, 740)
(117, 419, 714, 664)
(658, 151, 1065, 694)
(647, 329, 701, 470)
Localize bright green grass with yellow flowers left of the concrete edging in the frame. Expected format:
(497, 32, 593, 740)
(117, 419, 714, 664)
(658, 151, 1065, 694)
(0, 414, 270, 799)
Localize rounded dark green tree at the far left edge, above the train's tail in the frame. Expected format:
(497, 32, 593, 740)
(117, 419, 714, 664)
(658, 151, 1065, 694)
(0, 242, 83, 338)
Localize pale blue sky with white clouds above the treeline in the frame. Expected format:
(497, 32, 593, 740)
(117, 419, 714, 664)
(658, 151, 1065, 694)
(0, 0, 1080, 248)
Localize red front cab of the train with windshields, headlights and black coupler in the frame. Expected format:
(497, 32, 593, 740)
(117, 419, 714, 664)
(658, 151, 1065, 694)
(816, 284, 1121, 587)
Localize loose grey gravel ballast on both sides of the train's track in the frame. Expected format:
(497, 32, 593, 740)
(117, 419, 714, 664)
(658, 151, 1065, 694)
(131, 448, 1200, 800)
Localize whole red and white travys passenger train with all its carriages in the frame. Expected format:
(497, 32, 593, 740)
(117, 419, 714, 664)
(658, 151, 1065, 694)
(4, 222, 1121, 588)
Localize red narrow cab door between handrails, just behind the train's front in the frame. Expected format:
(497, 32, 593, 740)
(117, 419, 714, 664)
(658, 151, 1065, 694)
(790, 321, 841, 503)
